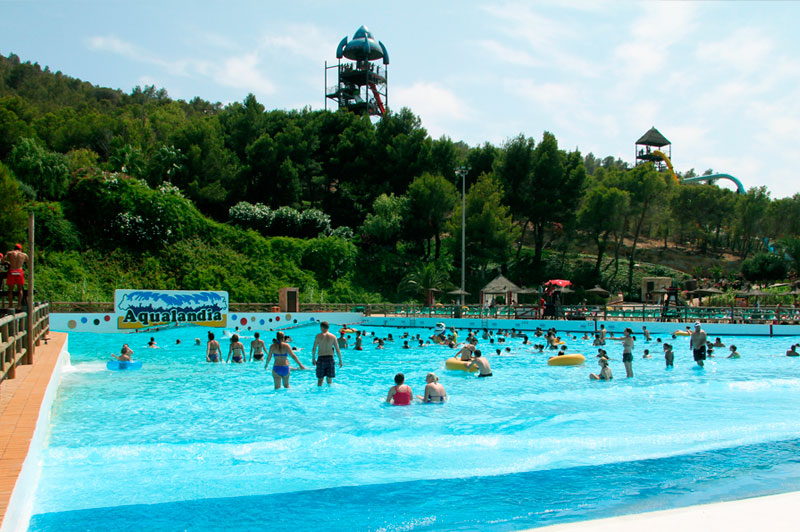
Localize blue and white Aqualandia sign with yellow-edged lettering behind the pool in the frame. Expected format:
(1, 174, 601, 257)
(114, 290, 228, 329)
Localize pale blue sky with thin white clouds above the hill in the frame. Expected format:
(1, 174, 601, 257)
(0, 0, 800, 197)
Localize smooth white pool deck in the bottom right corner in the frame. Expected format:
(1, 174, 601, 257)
(528, 491, 800, 532)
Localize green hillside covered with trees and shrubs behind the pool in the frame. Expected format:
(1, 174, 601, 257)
(0, 54, 800, 302)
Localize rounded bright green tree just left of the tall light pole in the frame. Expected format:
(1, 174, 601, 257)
(406, 173, 458, 260)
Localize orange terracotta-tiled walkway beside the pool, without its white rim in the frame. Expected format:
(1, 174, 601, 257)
(0, 332, 67, 525)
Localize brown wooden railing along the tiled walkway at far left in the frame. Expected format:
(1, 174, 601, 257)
(0, 303, 50, 381)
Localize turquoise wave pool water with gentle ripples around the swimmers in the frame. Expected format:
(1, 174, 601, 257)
(30, 327, 800, 531)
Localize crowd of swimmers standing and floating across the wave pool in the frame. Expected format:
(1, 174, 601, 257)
(111, 321, 800, 405)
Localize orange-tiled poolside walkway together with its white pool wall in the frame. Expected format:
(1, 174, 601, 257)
(0, 332, 69, 532)
